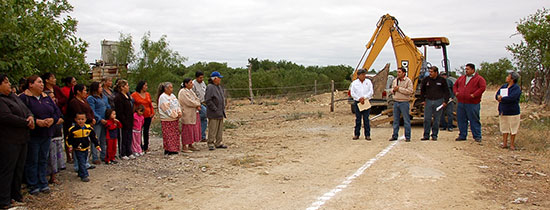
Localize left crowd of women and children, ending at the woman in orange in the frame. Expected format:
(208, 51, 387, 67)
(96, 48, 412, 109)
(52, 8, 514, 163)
(0, 73, 154, 208)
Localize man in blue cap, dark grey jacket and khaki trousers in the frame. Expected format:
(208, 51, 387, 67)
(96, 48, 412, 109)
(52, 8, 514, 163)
(204, 71, 227, 150)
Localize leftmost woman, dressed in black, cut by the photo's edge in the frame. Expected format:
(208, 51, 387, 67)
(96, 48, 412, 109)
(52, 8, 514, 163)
(0, 74, 35, 209)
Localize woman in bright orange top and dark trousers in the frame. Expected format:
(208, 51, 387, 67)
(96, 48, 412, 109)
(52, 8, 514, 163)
(131, 80, 155, 152)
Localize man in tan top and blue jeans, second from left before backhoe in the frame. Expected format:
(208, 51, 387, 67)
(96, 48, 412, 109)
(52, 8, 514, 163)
(390, 67, 414, 142)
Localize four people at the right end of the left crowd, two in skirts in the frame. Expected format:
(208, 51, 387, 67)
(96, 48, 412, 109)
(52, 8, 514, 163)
(157, 71, 227, 155)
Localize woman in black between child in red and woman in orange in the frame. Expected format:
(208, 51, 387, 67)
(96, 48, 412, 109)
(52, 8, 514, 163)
(114, 79, 136, 160)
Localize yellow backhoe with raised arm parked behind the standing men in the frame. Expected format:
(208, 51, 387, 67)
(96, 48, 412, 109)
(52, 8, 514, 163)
(352, 14, 449, 125)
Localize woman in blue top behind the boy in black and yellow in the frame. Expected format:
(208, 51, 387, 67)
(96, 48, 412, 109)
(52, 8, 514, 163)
(87, 82, 111, 165)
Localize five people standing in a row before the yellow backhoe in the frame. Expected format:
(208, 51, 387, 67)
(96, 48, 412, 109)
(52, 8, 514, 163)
(350, 63, 521, 149)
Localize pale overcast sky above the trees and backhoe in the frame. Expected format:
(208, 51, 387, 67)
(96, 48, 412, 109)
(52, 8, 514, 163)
(69, 0, 550, 70)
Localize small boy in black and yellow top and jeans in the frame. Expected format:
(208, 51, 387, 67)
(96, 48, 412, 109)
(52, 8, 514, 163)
(67, 112, 101, 182)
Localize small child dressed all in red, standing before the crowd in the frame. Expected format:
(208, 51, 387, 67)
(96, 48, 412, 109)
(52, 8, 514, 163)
(105, 109, 122, 164)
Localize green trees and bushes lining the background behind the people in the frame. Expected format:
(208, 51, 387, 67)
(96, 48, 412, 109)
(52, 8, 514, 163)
(0, 0, 550, 104)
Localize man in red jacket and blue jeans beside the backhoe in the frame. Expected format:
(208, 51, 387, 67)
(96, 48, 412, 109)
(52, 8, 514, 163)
(453, 63, 487, 142)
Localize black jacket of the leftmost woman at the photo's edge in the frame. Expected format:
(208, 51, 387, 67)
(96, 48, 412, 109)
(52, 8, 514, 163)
(0, 93, 32, 144)
